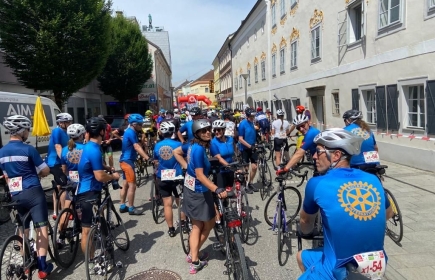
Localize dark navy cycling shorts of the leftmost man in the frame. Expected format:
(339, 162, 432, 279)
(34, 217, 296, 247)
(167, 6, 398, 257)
(12, 187, 48, 229)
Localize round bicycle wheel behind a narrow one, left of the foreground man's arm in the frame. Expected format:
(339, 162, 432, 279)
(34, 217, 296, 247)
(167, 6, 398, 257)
(264, 186, 302, 226)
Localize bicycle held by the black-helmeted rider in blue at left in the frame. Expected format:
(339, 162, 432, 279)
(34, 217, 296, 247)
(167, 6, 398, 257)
(85, 180, 130, 279)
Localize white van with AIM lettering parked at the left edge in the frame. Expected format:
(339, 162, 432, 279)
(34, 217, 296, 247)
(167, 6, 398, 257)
(0, 91, 60, 153)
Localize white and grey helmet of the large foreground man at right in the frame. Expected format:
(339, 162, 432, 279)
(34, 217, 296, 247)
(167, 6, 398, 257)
(314, 128, 364, 155)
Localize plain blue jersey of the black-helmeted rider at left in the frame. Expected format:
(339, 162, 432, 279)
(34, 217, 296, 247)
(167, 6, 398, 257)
(77, 141, 104, 194)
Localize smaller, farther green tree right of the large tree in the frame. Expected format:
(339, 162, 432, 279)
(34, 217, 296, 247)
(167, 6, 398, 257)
(97, 15, 153, 110)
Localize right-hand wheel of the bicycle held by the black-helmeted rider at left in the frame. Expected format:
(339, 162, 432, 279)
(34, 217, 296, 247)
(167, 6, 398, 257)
(106, 204, 130, 251)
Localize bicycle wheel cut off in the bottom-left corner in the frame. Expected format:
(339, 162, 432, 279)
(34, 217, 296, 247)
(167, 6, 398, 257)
(0, 235, 32, 279)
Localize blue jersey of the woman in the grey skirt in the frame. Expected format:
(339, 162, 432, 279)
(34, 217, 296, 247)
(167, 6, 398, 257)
(186, 143, 210, 193)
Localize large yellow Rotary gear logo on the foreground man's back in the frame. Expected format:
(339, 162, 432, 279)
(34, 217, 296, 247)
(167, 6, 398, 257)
(337, 181, 381, 221)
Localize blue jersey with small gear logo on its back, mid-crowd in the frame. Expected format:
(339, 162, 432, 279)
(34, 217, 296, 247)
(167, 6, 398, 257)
(154, 138, 182, 178)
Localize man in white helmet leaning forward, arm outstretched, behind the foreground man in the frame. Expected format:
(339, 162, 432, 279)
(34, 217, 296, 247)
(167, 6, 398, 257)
(276, 114, 320, 176)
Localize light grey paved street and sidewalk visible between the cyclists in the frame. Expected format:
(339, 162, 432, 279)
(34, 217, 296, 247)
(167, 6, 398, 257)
(0, 152, 435, 280)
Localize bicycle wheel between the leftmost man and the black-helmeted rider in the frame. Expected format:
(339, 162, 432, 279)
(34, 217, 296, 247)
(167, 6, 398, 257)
(52, 208, 81, 269)
